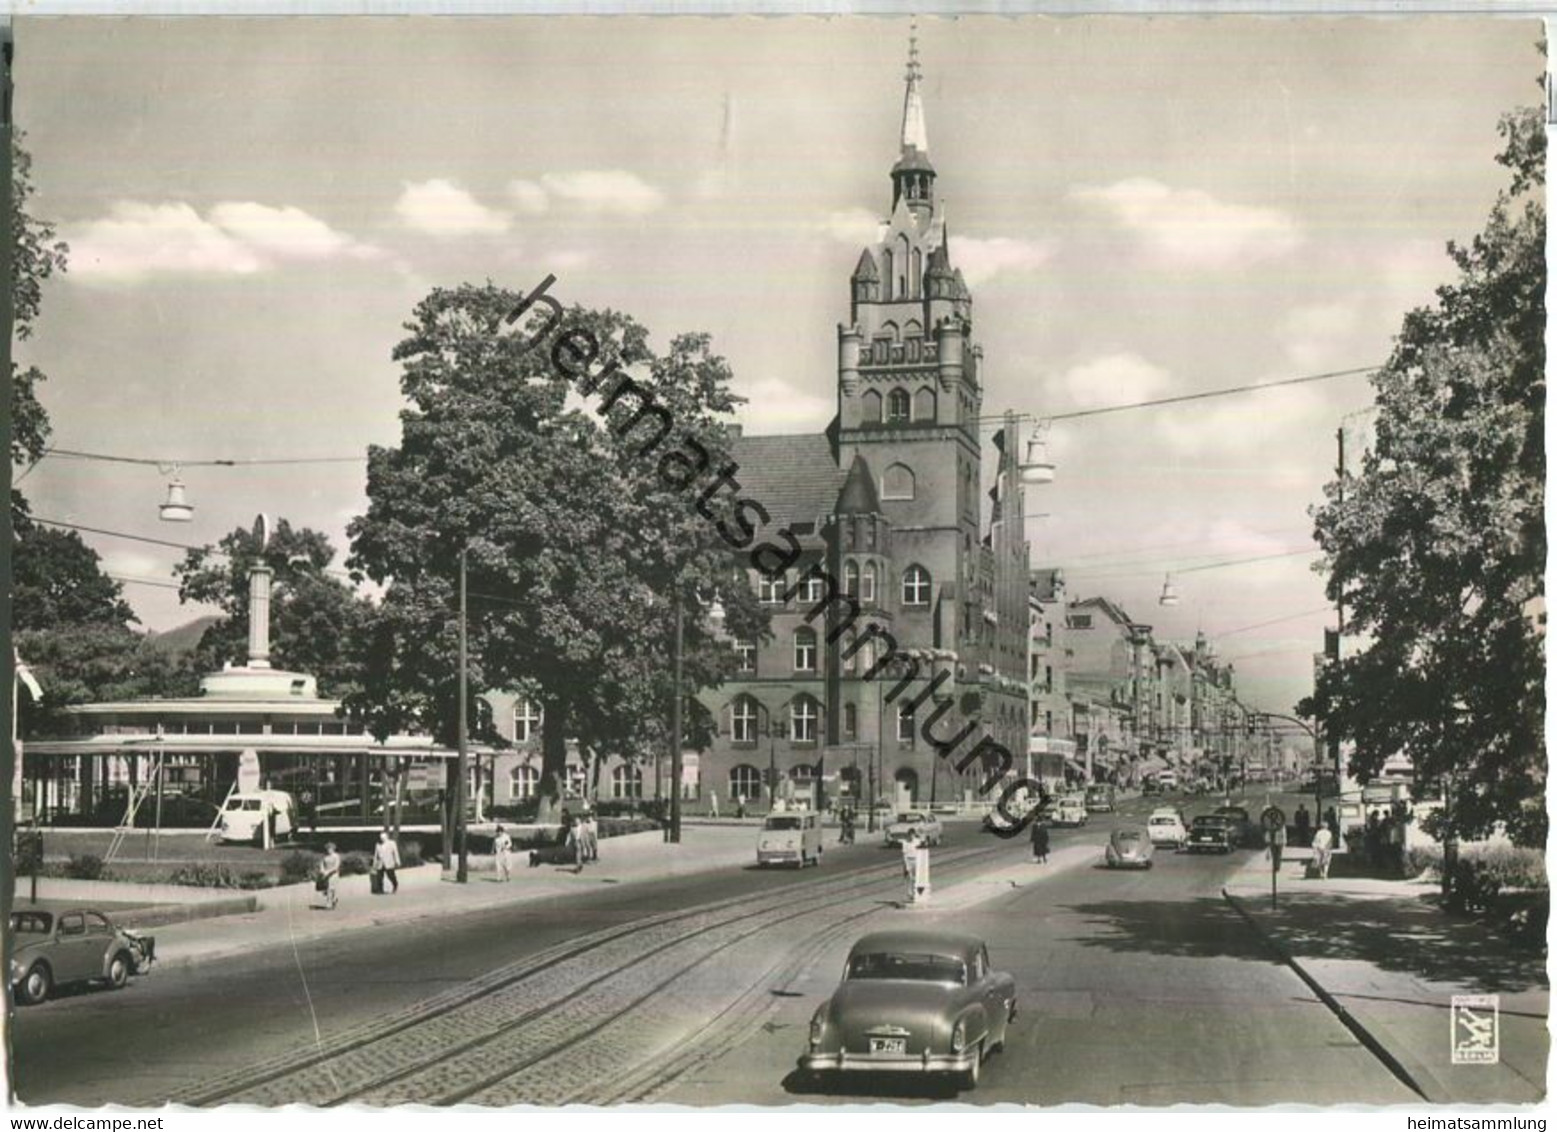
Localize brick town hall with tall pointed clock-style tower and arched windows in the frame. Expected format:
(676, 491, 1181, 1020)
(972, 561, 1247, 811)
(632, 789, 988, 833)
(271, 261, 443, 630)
(694, 48, 1043, 813)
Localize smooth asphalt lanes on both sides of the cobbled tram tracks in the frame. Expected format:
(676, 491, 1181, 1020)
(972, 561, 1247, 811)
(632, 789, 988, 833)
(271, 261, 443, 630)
(12, 787, 1411, 1106)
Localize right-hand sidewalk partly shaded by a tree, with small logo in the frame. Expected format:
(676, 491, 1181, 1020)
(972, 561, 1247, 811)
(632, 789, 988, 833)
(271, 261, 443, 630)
(1225, 853, 1549, 1104)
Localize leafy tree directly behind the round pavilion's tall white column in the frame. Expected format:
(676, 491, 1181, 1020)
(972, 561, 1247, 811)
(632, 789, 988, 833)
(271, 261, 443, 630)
(174, 519, 372, 696)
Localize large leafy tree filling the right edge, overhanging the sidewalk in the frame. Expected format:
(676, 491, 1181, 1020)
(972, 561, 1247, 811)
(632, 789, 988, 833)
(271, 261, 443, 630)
(1299, 101, 1546, 844)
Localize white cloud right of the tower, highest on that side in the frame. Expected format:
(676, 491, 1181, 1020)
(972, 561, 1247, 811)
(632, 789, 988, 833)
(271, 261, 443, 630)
(1070, 178, 1303, 268)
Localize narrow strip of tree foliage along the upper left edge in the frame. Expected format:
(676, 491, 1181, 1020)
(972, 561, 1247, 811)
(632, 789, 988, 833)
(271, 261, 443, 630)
(11, 132, 70, 515)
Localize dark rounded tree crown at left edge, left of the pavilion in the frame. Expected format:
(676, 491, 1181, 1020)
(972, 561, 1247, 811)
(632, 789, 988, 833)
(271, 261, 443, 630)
(11, 522, 137, 632)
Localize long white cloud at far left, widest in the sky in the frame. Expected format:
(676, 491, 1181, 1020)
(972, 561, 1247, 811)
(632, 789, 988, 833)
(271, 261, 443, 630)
(65, 201, 381, 283)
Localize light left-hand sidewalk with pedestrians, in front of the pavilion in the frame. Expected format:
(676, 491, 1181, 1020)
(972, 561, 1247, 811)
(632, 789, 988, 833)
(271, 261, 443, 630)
(143, 825, 755, 969)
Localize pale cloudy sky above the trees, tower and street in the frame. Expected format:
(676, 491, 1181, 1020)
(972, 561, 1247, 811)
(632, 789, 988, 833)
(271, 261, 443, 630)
(16, 17, 1541, 712)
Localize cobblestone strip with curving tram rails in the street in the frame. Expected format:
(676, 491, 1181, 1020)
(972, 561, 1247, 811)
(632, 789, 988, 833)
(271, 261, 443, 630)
(174, 849, 990, 1106)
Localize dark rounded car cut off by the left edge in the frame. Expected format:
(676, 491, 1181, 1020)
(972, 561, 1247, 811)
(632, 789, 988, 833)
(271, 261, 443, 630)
(11, 908, 156, 1003)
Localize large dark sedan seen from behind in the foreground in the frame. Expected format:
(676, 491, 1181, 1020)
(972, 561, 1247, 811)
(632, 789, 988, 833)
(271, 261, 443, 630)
(800, 931, 1017, 1088)
